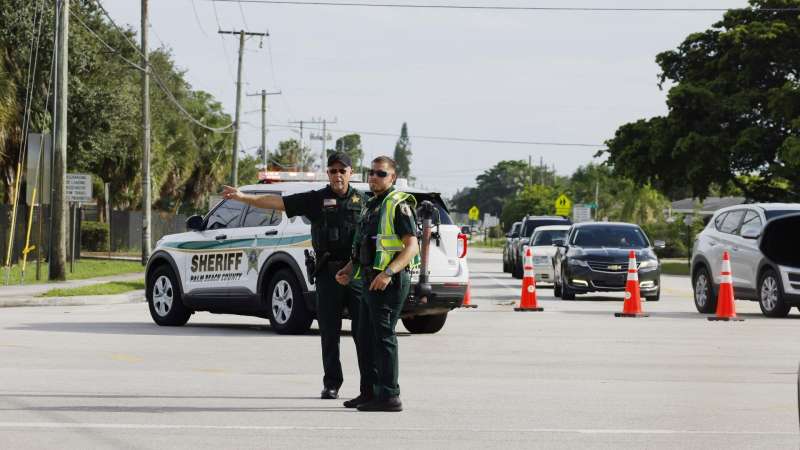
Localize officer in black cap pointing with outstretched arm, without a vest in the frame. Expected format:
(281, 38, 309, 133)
(223, 152, 376, 399)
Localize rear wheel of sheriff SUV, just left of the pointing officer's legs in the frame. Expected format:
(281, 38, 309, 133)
(265, 269, 314, 334)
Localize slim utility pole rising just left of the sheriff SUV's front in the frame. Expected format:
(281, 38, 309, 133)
(141, 0, 152, 266)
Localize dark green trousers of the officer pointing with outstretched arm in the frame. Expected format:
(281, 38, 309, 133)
(316, 270, 375, 392)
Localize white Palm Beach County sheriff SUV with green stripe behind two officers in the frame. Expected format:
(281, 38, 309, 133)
(145, 182, 469, 334)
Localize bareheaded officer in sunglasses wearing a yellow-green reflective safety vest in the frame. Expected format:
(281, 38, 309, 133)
(336, 156, 419, 411)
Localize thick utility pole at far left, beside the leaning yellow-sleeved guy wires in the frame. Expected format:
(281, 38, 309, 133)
(48, 0, 69, 280)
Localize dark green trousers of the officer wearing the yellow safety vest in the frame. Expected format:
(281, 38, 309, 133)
(364, 270, 411, 399)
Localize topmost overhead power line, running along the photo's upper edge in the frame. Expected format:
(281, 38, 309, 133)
(207, 0, 800, 13)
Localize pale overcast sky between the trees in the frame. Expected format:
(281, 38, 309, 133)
(100, 0, 747, 195)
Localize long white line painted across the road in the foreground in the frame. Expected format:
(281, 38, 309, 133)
(0, 422, 797, 436)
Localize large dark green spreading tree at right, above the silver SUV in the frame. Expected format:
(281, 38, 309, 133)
(607, 0, 800, 201)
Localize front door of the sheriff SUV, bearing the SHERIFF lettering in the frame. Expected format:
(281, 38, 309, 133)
(184, 200, 252, 294)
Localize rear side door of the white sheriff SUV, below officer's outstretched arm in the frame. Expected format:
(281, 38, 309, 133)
(231, 192, 283, 294)
